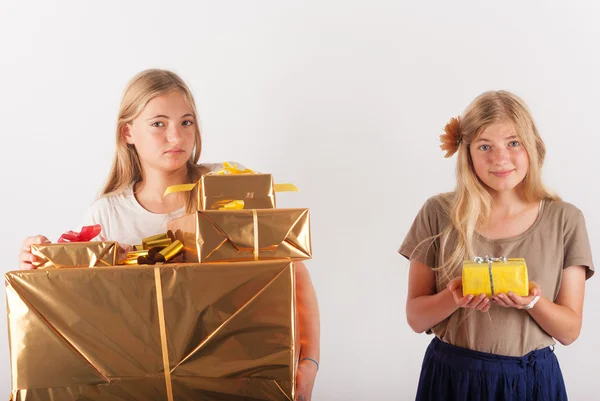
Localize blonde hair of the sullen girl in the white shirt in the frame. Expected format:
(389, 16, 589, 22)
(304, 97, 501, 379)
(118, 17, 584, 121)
(100, 69, 203, 212)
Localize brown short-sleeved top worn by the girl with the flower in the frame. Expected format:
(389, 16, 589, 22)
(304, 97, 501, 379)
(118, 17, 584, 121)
(399, 194, 594, 356)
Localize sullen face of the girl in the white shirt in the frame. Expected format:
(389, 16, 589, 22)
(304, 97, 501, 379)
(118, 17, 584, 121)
(123, 91, 196, 173)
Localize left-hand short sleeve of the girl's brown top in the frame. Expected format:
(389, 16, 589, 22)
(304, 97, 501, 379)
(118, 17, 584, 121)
(398, 198, 440, 267)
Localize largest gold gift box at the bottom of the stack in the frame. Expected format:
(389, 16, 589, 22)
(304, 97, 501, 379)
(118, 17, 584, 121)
(5, 260, 299, 401)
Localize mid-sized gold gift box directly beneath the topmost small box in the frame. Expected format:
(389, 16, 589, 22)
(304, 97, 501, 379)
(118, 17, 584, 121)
(168, 209, 312, 263)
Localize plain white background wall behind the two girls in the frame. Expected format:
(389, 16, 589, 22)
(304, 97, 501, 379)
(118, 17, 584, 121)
(0, 0, 600, 401)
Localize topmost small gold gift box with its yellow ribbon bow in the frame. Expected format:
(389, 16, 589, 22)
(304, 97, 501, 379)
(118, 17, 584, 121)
(164, 163, 298, 210)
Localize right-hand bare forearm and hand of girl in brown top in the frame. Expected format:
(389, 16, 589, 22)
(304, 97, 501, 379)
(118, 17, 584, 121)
(495, 266, 586, 345)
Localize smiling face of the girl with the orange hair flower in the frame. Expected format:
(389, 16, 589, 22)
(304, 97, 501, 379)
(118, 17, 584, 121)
(469, 123, 529, 192)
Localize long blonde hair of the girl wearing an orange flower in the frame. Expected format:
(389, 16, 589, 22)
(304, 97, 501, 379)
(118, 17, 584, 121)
(437, 91, 559, 277)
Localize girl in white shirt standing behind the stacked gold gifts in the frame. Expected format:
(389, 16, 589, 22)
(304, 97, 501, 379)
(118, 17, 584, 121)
(20, 69, 320, 401)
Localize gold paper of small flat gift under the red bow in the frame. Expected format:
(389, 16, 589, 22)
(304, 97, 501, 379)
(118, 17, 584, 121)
(31, 241, 117, 269)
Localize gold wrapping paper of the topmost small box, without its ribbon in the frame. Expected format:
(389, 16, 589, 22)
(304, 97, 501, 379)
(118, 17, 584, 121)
(198, 174, 276, 210)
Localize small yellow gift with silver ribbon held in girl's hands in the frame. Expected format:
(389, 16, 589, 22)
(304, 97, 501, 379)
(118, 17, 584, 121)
(462, 258, 529, 297)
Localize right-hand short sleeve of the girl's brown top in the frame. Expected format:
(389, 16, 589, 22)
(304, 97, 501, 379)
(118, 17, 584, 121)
(563, 210, 594, 279)
